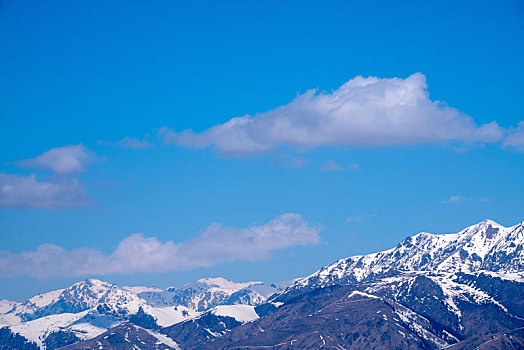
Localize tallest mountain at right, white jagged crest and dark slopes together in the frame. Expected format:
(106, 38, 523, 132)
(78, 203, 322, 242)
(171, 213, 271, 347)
(206, 220, 524, 349)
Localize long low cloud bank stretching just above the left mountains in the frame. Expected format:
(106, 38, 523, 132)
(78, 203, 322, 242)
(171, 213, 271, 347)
(0, 214, 321, 278)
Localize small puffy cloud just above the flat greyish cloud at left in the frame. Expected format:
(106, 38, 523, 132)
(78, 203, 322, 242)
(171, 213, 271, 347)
(17, 144, 96, 174)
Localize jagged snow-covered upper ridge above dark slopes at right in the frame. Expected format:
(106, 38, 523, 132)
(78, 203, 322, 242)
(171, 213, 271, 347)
(291, 220, 524, 289)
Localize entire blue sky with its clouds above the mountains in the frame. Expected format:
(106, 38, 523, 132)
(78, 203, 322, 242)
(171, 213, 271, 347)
(0, 0, 524, 300)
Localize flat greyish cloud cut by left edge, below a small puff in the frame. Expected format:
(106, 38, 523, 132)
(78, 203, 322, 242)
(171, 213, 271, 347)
(0, 173, 89, 209)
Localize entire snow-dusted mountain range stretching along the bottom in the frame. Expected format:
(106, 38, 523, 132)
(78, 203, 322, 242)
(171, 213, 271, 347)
(0, 220, 524, 350)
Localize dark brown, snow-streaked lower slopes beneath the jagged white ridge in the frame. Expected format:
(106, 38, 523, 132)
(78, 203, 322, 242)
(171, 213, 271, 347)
(207, 273, 524, 350)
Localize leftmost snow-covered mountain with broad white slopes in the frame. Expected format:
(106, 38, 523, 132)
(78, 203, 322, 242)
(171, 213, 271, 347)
(0, 279, 154, 347)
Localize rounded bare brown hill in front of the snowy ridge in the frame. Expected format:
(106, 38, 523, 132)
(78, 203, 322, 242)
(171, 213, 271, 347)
(201, 287, 445, 349)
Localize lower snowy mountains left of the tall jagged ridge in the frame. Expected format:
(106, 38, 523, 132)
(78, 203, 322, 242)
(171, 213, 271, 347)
(0, 278, 282, 348)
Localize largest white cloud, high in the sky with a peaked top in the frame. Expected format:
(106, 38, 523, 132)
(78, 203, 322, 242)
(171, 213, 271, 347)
(160, 73, 502, 155)
